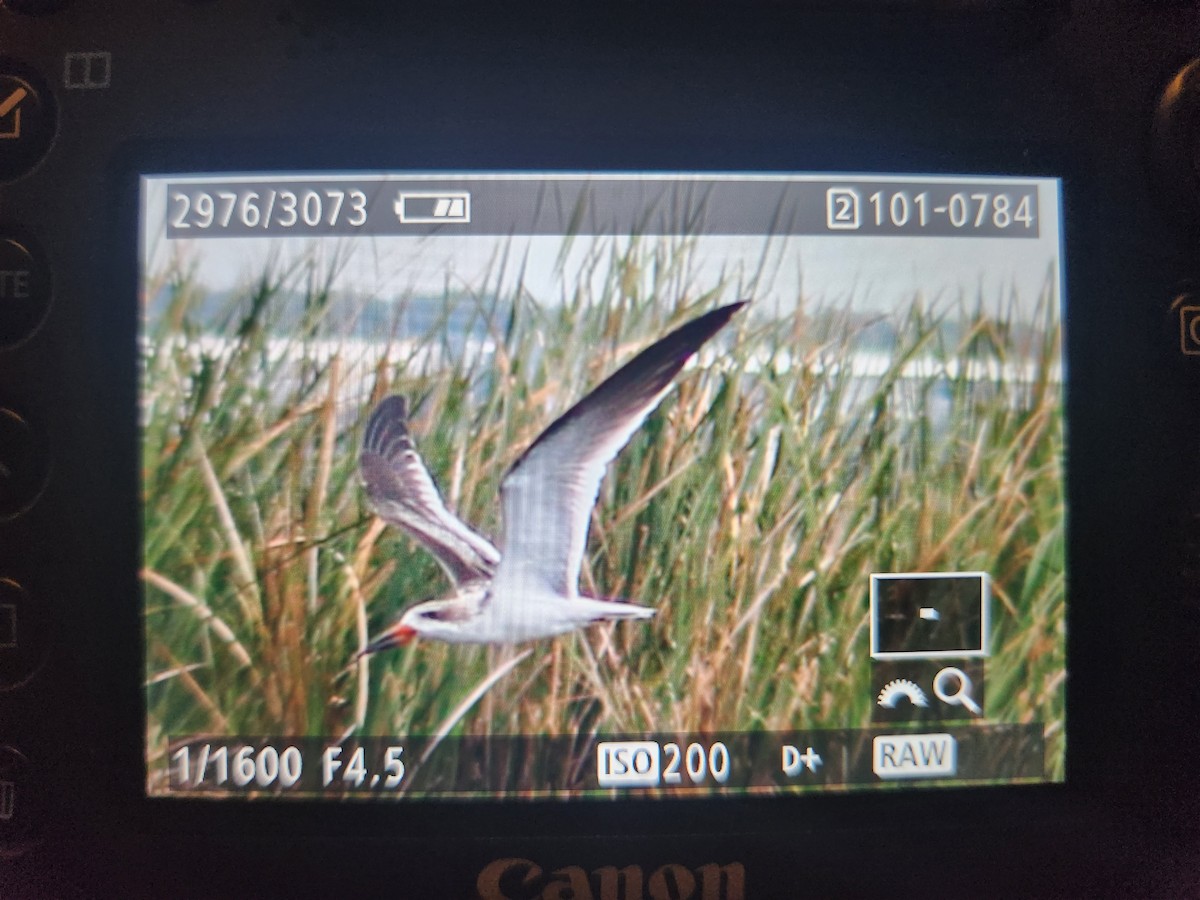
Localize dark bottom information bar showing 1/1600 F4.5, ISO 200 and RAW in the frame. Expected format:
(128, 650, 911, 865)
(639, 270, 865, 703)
(158, 722, 1044, 797)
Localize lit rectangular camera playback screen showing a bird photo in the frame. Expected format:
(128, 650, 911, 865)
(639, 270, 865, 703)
(139, 172, 1067, 800)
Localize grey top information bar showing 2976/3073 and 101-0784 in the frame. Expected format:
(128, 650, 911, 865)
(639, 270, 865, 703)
(164, 175, 1040, 239)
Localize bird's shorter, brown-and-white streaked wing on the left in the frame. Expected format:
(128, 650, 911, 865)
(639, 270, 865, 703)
(359, 396, 500, 584)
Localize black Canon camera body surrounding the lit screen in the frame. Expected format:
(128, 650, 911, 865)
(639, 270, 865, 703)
(0, 0, 1200, 898)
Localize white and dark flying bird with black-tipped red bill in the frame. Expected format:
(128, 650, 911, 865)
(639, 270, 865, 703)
(359, 301, 745, 656)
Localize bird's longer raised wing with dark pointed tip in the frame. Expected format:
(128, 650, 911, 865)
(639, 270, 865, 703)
(496, 302, 745, 596)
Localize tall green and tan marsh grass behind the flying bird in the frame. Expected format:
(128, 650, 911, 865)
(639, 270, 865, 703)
(142, 237, 1064, 775)
